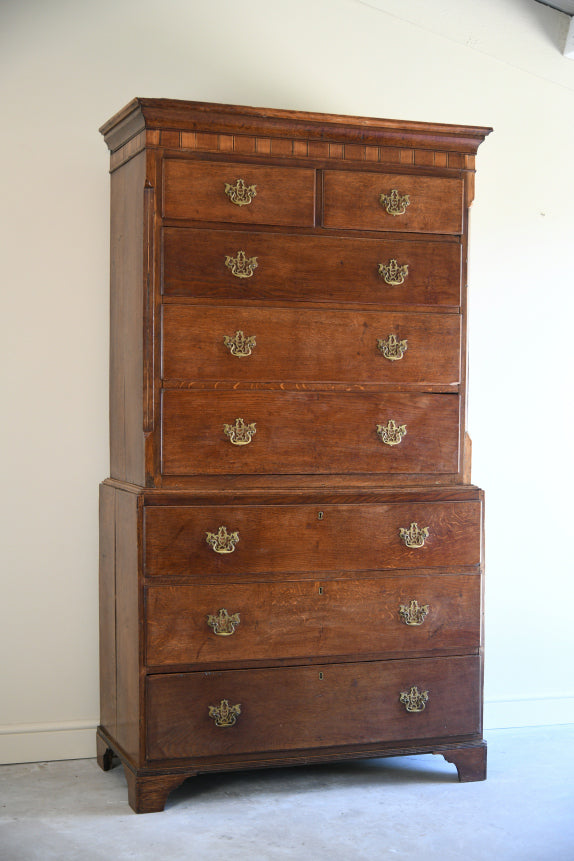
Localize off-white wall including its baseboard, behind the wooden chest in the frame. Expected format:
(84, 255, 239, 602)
(0, 0, 574, 761)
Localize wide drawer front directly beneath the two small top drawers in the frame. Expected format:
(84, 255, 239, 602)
(163, 227, 461, 308)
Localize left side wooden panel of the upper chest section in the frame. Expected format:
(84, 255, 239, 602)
(110, 152, 146, 484)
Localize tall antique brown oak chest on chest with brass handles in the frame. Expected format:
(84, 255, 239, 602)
(98, 99, 490, 812)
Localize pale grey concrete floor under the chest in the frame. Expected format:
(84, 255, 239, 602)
(0, 725, 574, 861)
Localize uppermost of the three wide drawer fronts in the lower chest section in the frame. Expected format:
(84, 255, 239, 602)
(144, 500, 481, 576)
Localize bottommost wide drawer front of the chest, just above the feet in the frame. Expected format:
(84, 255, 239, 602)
(147, 657, 481, 760)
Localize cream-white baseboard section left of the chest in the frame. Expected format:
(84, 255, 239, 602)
(0, 720, 97, 765)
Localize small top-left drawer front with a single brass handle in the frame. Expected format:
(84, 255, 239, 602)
(163, 159, 315, 227)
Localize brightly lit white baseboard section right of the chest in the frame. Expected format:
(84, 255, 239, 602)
(484, 696, 574, 731)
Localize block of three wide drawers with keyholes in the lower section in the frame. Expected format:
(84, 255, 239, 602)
(140, 491, 482, 766)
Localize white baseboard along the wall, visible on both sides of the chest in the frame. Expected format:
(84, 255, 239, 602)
(0, 696, 574, 765)
